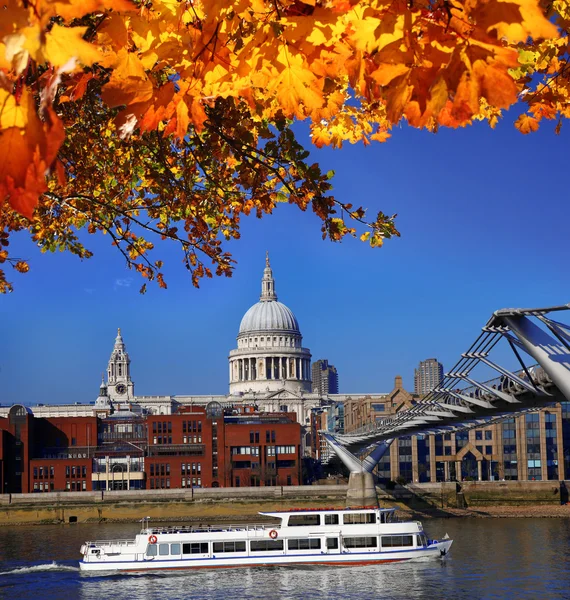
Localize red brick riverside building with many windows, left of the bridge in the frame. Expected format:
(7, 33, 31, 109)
(0, 402, 301, 493)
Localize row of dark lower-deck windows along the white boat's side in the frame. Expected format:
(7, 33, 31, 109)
(146, 534, 427, 556)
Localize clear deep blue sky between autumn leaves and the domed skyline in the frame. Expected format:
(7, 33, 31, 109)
(0, 116, 570, 405)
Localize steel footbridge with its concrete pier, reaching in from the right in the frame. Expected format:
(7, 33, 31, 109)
(321, 304, 570, 505)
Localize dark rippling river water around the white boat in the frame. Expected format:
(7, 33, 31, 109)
(0, 519, 570, 600)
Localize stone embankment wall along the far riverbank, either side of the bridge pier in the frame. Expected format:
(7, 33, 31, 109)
(0, 481, 570, 525)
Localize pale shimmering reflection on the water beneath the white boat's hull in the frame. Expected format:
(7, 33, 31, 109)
(75, 561, 451, 600)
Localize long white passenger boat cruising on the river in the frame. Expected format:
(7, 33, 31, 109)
(79, 507, 452, 572)
